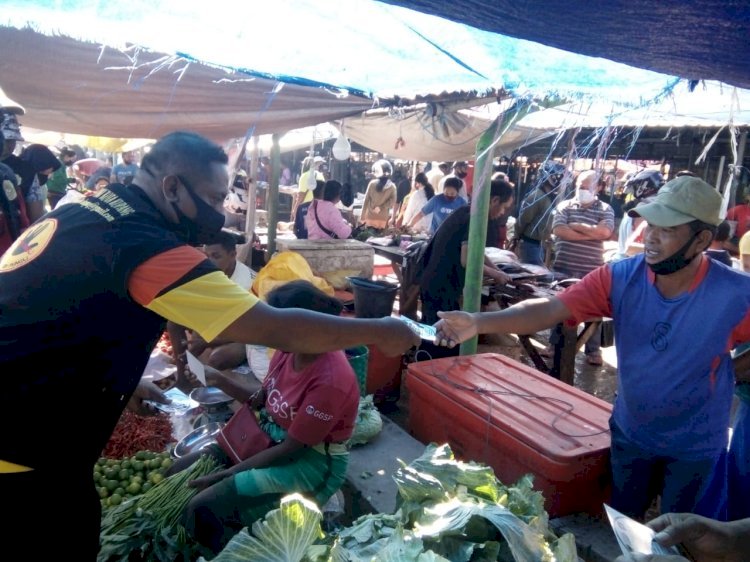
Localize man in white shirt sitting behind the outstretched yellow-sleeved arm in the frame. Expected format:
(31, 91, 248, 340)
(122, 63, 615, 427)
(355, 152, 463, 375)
(167, 232, 255, 370)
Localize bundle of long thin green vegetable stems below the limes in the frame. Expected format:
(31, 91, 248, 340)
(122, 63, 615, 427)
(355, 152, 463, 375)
(97, 455, 221, 562)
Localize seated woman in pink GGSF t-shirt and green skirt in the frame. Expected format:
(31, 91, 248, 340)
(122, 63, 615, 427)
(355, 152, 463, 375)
(185, 280, 359, 552)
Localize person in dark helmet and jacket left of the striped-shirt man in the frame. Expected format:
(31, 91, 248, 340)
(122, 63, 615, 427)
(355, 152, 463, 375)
(510, 160, 565, 265)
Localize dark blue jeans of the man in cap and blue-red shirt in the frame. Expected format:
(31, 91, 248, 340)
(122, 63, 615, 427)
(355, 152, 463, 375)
(609, 420, 727, 521)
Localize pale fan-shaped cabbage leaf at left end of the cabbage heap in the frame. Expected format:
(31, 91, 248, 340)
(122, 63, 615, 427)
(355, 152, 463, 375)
(206, 494, 323, 562)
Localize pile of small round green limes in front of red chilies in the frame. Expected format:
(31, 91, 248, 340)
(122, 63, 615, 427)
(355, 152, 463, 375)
(94, 451, 172, 509)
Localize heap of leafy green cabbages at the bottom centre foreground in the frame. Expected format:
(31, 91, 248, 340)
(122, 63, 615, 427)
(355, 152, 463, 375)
(209, 445, 578, 562)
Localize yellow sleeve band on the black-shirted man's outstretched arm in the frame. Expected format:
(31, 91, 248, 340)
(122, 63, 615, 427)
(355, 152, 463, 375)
(146, 271, 258, 341)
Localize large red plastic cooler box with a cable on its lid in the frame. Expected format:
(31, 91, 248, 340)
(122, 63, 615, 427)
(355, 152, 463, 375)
(406, 353, 612, 517)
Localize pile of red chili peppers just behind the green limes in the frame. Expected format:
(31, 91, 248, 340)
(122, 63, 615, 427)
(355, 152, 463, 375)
(102, 410, 174, 459)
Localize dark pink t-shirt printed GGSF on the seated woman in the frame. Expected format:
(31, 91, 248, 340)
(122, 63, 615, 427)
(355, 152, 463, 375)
(263, 351, 359, 446)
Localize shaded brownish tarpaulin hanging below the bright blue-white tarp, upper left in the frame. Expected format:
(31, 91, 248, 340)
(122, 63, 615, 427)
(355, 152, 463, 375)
(0, 28, 372, 141)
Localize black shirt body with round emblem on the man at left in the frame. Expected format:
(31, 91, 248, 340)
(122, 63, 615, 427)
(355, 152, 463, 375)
(0, 185, 191, 468)
